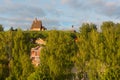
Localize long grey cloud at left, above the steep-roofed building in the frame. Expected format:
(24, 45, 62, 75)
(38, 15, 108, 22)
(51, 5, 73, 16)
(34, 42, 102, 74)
(0, 4, 45, 17)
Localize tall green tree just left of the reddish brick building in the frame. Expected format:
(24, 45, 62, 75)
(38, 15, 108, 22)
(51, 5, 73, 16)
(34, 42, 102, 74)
(7, 30, 33, 80)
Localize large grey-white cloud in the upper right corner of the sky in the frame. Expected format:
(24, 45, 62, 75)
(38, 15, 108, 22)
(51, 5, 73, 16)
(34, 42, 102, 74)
(61, 0, 120, 17)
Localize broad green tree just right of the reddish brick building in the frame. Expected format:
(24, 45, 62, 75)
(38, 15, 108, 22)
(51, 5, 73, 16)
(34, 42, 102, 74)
(40, 31, 77, 80)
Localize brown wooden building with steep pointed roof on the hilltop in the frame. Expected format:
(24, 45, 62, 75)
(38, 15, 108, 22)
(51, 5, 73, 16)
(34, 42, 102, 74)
(30, 18, 47, 31)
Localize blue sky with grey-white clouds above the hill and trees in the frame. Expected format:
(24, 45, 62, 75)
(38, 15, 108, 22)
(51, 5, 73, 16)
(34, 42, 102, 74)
(0, 0, 120, 30)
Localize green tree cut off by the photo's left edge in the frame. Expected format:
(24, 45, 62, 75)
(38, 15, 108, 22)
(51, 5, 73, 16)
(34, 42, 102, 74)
(0, 32, 12, 80)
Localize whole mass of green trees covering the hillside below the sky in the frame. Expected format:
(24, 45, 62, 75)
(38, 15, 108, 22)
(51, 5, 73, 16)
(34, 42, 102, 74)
(0, 21, 120, 80)
